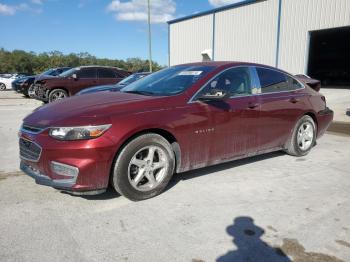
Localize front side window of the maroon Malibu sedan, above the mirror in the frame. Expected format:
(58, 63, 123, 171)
(201, 67, 252, 96)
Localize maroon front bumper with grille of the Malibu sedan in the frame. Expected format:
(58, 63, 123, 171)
(20, 130, 116, 195)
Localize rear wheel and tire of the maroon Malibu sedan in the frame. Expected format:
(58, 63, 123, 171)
(285, 115, 316, 156)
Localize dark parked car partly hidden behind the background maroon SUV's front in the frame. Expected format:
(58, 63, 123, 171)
(12, 67, 71, 97)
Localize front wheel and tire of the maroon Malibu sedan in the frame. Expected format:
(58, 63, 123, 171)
(111, 133, 175, 201)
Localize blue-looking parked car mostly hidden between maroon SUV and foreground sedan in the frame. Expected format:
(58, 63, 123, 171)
(76, 72, 150, 95)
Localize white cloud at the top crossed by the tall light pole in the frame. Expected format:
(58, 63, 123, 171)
(107, 0, 176, 23)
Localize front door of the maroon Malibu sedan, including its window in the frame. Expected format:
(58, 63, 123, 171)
(191, 67, 259, 163)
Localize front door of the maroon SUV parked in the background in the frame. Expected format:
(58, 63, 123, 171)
(71, 67, 98, 95)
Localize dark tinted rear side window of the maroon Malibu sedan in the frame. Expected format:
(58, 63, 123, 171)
(256, 67, 302, 93)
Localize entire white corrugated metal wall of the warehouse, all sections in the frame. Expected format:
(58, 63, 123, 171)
(169, 0, 350, 73)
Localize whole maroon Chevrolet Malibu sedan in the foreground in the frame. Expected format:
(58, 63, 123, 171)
(19, 62, 333, 200)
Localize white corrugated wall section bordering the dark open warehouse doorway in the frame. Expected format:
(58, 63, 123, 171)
(279, 0, 350, 74)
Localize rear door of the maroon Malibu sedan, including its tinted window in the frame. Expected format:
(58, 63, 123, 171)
(256, 67, 305, 151)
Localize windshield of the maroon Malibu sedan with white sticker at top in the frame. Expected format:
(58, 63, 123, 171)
(121, 65, 215, 96)
